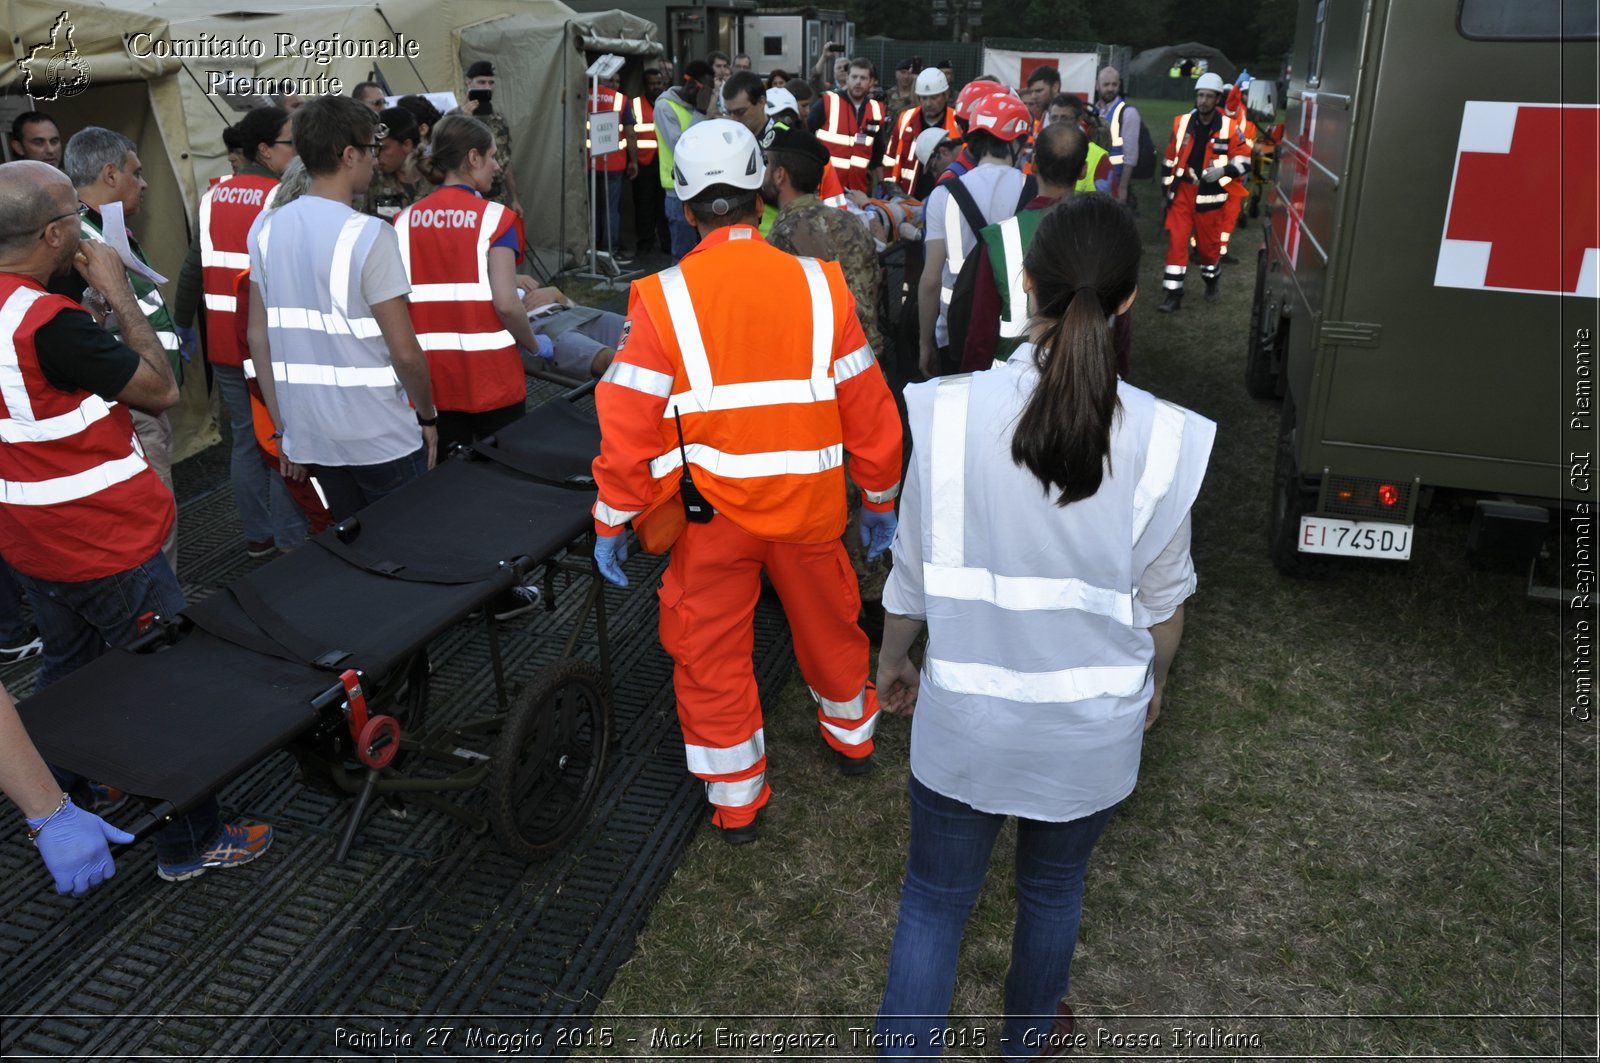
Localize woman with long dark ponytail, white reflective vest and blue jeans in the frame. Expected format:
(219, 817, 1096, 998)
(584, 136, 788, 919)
(877, 194, 1216, 1060)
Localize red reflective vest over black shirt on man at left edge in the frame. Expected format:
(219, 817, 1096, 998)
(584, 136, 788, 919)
(0, 274, 176, 583)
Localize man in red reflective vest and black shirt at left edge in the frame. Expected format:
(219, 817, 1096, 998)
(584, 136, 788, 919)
(0, 160, 272, 882)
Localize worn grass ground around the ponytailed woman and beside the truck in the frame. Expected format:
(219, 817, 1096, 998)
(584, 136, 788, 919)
(576, 101, 1597, 1058)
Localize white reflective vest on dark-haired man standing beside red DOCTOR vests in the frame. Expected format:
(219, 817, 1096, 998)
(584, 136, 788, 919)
(248, 195, 422, 466)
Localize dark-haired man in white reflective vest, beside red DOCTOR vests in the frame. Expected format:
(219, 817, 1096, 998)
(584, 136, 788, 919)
(248, 96, 438, 520)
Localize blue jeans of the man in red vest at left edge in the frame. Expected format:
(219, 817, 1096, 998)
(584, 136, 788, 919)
(16, 554, 222, 863)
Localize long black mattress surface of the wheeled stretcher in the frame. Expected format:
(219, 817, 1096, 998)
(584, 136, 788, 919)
(19, 402, 598, 808)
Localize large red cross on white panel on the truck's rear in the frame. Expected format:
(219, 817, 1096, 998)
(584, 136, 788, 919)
(1434, 101, 1600, 298)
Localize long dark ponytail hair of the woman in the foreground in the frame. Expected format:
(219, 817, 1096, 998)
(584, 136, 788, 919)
(1011, 192, 1141, 506)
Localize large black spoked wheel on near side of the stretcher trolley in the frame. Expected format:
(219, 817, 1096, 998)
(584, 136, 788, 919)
(488, 660, 611, 861)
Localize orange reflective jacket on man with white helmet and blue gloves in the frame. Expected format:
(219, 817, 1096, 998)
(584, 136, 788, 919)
(594, 226, 901, 543)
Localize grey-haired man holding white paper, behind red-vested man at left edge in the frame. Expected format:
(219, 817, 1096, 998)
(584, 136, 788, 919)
(50, 125, 184, 572)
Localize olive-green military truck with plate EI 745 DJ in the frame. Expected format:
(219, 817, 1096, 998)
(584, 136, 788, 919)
(1235, 0, 1600, 575)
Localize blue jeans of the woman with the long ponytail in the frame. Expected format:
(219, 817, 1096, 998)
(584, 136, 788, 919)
(877, 775, 1112, 1060)
